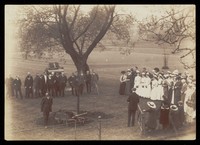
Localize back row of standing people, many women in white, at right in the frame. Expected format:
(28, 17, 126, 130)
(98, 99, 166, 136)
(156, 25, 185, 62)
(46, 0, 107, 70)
(119, 68, 196, 127)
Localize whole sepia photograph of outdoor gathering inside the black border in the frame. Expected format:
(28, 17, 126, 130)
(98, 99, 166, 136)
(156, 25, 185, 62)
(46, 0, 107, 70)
(4, 4, 196, 141)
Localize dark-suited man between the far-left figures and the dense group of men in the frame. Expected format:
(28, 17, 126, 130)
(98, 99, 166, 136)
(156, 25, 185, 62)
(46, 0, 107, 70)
(24, 72, 33, 98)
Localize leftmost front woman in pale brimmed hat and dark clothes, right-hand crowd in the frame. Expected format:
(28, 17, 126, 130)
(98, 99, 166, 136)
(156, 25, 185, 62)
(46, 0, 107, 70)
(143, 101, 157, 131)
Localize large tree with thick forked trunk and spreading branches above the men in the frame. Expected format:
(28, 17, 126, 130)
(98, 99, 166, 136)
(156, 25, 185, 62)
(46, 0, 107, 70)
(19, 5, 135, 73)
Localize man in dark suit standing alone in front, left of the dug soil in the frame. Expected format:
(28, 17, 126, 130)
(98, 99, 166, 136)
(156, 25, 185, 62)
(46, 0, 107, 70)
(41, 93, 53, 128)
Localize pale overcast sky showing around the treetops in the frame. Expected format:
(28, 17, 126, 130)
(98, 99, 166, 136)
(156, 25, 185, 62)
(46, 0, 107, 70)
(5, 5, 195, 52)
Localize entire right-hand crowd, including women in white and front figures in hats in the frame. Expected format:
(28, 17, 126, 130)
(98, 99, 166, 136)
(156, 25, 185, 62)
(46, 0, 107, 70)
(123, 67, 196, 130)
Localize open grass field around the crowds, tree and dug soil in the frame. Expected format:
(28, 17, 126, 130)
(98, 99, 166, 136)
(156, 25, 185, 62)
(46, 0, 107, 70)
(5, 49, 196, 140)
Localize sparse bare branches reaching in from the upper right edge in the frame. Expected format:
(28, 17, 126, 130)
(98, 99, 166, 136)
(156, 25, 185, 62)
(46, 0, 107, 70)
(138, 6, 196, 69)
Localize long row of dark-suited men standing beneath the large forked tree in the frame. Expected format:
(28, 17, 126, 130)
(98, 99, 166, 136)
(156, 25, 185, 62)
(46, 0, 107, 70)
(6, 70, 99, 99)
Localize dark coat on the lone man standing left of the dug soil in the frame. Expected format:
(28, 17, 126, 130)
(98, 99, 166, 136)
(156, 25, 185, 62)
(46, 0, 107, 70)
(41, 97, 53, 112)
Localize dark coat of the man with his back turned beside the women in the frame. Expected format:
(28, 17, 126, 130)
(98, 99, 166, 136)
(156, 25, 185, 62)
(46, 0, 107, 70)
(127, 92, 139, 110)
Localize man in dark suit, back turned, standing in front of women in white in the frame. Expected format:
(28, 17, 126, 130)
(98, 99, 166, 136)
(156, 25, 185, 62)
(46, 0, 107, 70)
(127, 88, 139, 127)
